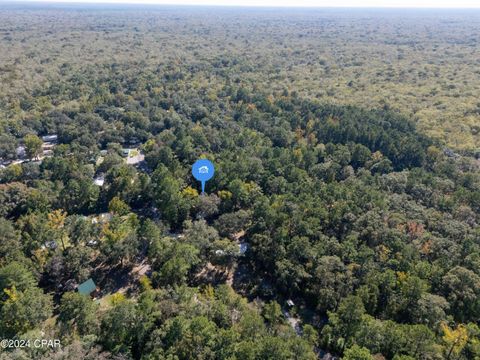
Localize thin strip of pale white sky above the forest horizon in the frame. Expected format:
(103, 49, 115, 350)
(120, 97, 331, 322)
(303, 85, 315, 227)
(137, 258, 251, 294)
(7, 0, 480, 8)
